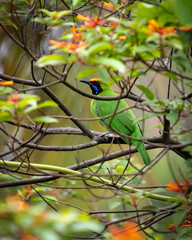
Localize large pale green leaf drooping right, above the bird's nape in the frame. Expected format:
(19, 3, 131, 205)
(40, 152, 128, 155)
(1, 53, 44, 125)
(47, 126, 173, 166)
(90, 57, 126, 73)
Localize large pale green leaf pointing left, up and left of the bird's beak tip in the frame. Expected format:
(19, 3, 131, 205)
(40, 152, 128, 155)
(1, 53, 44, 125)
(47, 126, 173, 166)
(37, 55, 67, 67)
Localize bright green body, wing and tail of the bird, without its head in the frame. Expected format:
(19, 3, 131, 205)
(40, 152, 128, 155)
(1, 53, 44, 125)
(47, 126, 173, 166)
(91, 97, 150, 165)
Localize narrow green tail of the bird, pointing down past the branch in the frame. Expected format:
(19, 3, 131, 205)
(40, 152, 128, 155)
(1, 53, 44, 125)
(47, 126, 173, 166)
(131, 126, 151, 165)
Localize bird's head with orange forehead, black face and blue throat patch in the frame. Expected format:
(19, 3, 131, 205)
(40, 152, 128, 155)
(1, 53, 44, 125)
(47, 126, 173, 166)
(80, 78, 109, 95)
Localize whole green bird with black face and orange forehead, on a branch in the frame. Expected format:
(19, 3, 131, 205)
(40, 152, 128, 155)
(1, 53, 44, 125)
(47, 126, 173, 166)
(80, 78, 150, 165)
